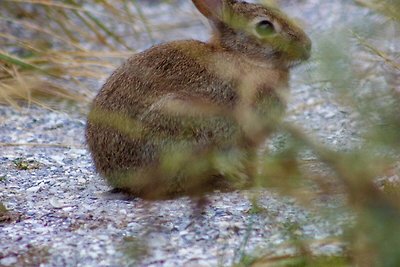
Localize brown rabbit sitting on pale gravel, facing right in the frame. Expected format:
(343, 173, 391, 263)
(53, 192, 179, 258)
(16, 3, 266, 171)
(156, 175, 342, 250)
(86, 0, 311, 199)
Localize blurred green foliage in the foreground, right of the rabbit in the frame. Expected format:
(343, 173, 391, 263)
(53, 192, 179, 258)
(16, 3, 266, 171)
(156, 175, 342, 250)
(237, 0, 400, 267)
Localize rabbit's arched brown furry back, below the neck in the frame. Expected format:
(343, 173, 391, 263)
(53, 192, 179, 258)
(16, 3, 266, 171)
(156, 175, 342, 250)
(94, 40, 241, 116)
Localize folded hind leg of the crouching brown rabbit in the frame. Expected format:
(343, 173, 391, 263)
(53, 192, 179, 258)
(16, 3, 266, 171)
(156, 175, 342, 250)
(140, 93, 246, 196)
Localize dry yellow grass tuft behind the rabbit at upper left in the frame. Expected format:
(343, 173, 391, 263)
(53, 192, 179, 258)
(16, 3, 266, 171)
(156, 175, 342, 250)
(0, 0, 181, 107)
